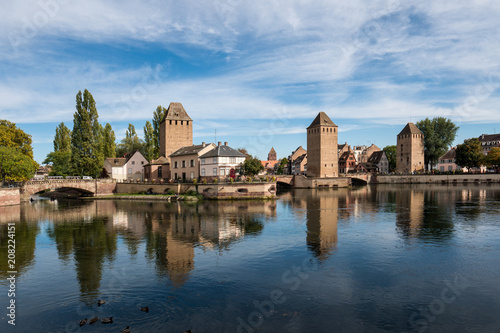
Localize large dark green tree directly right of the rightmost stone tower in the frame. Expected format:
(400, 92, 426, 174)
(415, 117, 459, 170)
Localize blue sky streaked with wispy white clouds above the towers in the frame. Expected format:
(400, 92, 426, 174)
(0, 0, 500, 163)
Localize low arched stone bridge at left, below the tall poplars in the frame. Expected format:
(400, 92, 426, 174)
(20, 179, 116, 201)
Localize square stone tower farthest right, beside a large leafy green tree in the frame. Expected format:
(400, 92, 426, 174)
(396, 123, 425, 174)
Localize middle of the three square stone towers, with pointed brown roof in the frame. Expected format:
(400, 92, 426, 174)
(307, 112, 339, 178)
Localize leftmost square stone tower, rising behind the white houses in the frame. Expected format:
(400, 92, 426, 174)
(160, 103, 193, 161)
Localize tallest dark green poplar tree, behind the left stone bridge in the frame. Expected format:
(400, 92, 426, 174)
(71, 89, 104, 176)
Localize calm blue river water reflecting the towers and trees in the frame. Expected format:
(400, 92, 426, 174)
(0, 185, 500, 333)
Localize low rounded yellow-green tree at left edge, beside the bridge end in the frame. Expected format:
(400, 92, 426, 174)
(0, 146, 38, 183)
